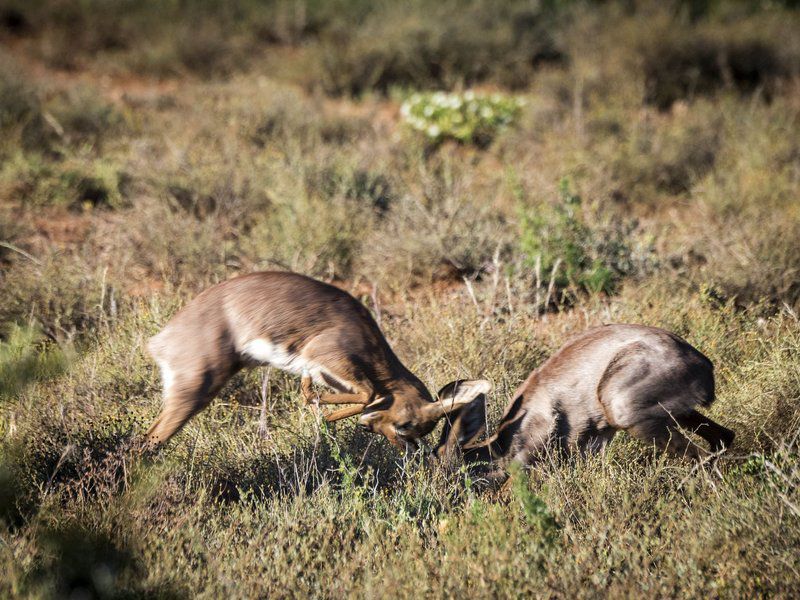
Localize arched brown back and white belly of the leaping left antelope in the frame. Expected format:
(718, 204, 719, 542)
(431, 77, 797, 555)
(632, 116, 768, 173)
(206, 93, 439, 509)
(148, 272, 402, 385)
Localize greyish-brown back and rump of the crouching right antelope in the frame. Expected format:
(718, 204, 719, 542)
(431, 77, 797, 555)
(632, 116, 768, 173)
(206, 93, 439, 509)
(515, 324, 714, 429)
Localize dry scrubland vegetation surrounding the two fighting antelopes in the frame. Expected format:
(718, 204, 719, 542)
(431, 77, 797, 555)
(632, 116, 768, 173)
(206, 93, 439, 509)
(0, 0, 800, 598)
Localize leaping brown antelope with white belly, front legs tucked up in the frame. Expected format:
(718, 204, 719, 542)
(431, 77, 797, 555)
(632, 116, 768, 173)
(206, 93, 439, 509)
(147, 272, 490, 448)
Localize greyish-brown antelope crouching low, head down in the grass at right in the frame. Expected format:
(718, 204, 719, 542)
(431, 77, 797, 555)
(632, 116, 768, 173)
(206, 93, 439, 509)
(435, 325, 734, 465)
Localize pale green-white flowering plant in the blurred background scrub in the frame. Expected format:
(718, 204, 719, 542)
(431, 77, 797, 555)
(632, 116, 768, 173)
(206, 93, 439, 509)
(400, 91, 523, 145)
